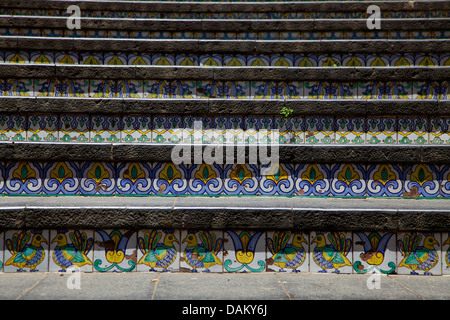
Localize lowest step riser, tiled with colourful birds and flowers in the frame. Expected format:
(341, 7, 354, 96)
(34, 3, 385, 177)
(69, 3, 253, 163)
(0, 229, 450, 275)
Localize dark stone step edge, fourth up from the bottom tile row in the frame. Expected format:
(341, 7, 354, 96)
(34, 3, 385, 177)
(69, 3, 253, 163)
(0, 63, 450, 82)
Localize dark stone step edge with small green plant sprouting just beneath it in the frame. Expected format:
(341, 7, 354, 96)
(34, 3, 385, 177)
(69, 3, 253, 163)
(0, 97, 442, 116)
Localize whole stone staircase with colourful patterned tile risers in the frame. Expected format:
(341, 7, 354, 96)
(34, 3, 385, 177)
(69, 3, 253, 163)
(0, 0, 450, 275)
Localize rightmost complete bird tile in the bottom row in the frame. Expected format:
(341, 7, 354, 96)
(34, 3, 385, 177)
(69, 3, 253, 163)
(397, 232, 442, 275)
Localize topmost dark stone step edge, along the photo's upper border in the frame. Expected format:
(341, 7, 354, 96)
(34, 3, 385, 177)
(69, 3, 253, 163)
(1, 0, 450, 14)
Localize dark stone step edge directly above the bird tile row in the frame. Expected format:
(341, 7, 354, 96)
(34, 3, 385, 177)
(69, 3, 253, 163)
(0, 207, 450, 232)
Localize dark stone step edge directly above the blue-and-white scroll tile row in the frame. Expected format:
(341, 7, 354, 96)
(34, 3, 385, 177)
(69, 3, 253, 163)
(0, 142, 450, 165)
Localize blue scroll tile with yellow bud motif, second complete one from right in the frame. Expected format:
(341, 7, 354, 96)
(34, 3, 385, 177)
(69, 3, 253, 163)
(367, 164, 403, 197)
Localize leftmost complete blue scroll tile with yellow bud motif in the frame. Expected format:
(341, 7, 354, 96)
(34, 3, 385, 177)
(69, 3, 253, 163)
(5, 161, 43, 194)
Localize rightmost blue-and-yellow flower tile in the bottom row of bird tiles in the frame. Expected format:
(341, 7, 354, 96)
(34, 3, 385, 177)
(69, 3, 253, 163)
(353, 232, 397, 274)
